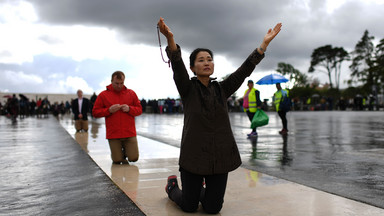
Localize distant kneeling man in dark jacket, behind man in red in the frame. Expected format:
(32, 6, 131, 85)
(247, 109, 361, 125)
(72, 89, 90, 132)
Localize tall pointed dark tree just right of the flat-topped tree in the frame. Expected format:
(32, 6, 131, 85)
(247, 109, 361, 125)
(348, 30, 378, 88)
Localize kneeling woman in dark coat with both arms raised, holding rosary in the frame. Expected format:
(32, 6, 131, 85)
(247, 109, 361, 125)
(158, 18, 281, 214)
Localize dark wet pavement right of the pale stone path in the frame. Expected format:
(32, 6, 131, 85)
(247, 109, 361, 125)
(136, 111, 384, 208)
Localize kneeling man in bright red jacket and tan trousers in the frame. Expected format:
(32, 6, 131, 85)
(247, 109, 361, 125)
(92, 71, 142, 164)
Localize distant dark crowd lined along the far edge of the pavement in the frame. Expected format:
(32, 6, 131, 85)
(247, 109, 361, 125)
(0, 93, 378, 118)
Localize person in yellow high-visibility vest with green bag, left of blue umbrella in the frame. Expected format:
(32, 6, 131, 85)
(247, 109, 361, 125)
(243, 80, 261, 137)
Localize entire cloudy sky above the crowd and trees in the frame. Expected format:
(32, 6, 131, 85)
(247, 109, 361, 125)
(0, 0, 384, 99)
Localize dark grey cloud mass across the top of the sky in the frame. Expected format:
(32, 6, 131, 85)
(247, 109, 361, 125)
(25, 0, 384, 72)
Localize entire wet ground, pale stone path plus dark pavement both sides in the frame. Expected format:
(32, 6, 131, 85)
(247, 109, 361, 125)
(0, 112, 384, 216)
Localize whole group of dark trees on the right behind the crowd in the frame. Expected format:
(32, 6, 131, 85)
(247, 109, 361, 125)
(276, 30, 384, 102)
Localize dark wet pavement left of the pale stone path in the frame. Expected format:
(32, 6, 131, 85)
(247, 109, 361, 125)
(0, 116, 144, 216)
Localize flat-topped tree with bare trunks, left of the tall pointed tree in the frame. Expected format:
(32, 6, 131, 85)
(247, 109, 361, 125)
(308, 45, 349, 89)
